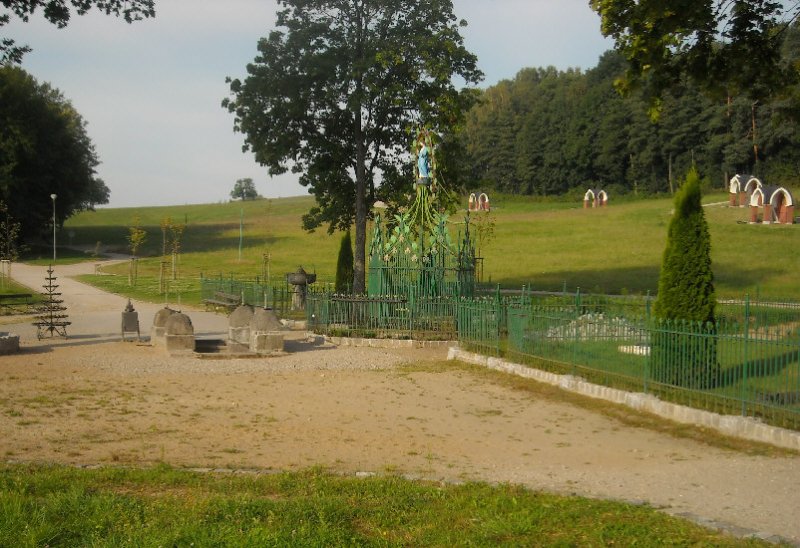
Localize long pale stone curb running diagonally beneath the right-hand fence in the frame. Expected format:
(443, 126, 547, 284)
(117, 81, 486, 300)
(447, 347, 800, 451)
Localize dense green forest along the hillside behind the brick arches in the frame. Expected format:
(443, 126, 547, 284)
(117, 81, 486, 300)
(462, 39, 800, 196)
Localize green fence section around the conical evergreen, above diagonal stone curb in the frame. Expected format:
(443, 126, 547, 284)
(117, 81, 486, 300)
(457, 294, 800, 429)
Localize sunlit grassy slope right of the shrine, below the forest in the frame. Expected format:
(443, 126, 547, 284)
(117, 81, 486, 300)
(484, 194, 800, 298)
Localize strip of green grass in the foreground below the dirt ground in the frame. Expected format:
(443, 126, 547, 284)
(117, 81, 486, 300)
(0, 465, 767, 546)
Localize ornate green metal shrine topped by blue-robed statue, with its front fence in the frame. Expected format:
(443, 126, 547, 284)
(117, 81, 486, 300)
(306, 131, 475, 340)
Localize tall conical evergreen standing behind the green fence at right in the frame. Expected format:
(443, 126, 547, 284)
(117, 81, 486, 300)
(652, 167, 719, 389)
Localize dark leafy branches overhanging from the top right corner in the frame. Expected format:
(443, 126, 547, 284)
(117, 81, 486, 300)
(590, 0, 800, 106)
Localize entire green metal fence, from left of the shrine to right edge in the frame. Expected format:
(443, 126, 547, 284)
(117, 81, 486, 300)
(201, 276, 800, 430)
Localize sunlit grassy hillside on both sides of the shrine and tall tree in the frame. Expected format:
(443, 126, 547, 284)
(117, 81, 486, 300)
(54, 194, 800, 300)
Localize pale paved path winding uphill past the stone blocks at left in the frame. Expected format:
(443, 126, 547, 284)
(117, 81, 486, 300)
(0, 260, 228, 345)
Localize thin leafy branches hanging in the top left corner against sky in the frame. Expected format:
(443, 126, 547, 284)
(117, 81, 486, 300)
(0, 0, 156, 64)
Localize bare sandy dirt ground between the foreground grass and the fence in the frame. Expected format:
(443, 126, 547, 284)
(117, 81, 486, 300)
(0, 265, 800, 545)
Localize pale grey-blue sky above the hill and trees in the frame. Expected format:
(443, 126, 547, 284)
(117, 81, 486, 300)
(0, 0, 612, 207)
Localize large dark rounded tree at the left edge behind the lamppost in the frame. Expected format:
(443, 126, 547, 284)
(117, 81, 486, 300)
(0, 66, 109, 238)
